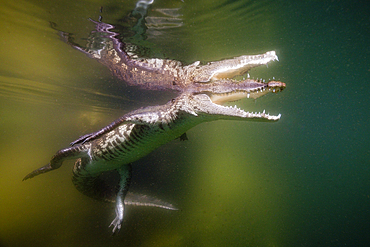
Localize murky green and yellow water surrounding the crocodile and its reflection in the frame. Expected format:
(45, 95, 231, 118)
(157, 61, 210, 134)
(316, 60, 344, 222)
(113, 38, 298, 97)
(0, 0, 370, 247)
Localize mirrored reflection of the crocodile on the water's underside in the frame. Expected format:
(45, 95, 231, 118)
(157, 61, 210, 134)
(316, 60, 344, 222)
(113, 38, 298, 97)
(60, 19, 278, 91)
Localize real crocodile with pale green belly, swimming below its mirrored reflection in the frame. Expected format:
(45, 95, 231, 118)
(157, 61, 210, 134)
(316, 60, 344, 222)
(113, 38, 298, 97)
(24, 79, 285, 233)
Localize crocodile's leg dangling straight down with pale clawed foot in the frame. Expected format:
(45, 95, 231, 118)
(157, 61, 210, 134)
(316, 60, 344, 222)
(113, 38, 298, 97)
(109, 164, 131, 234)
